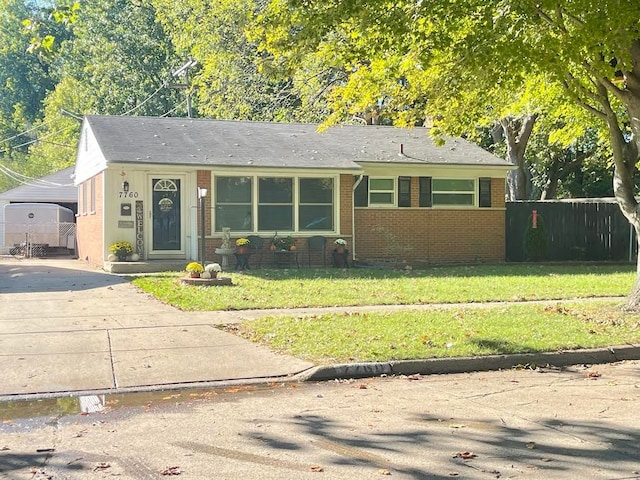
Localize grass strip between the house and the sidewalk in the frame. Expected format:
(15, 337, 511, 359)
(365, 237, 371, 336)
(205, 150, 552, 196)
(134, 265, 635, 310)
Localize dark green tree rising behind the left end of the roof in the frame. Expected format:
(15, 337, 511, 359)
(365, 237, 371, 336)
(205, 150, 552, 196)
(61, 0, 184, 115)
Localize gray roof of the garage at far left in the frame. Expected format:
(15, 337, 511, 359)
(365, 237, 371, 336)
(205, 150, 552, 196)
(0, 167, 78, 203)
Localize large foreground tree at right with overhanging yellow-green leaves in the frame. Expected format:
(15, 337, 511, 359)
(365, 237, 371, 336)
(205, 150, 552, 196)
(256, 0, 640, 310)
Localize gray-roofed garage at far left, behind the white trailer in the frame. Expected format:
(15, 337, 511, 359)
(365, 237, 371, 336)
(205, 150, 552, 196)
(0, 167, 78, 253)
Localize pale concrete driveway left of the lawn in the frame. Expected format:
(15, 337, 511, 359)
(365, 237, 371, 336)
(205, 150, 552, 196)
(0, 257, 312, 397)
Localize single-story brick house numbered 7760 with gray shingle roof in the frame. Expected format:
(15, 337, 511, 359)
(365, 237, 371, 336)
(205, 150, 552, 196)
(75, 116, 512, 266)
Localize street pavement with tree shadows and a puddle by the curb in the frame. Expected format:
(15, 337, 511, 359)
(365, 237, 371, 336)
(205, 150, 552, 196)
(0, 361, 640, 480)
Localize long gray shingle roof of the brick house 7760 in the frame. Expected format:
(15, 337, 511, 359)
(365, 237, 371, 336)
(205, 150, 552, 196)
(86, 116, 509, 170)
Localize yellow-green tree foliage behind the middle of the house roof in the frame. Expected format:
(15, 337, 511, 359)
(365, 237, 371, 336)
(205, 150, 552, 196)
(153, 0, 332, 121)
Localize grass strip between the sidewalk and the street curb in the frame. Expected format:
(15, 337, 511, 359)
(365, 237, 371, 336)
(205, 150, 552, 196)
(230, 300, 640, 364)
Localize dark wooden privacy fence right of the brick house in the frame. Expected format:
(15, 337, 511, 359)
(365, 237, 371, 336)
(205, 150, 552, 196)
(505, 199, 637, 262)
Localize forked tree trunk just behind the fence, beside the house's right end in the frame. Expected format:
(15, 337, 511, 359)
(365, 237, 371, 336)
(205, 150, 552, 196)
(500, 115, 538, 200)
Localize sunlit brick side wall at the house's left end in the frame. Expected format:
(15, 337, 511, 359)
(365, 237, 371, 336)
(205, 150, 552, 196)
(76, 173, 105, 268)
